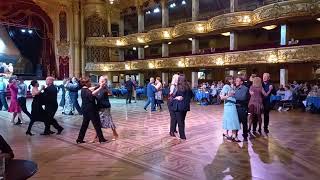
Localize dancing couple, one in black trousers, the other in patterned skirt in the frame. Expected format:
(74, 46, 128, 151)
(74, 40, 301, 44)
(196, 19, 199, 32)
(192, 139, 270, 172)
(76, 76, 118, 144)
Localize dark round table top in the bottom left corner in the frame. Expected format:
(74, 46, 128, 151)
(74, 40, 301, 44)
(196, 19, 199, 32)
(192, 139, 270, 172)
(6, 159, 38, 180)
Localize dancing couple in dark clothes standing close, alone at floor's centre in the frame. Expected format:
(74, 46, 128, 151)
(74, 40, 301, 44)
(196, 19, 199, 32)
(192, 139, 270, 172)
(168, 74, 193, 140)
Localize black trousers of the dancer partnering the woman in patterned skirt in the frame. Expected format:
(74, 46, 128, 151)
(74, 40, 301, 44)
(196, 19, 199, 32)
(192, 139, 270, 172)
(78, 116, 105, 142)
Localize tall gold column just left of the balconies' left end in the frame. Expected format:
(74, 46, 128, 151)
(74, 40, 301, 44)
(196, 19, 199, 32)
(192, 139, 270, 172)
(73, 1, 81, 77)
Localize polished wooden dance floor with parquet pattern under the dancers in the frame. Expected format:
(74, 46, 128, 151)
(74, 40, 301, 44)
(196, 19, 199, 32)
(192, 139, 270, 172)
(0, 100, 320, 180)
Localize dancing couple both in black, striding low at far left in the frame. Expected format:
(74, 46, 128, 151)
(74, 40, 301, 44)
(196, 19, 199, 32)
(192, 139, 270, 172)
(26, 77, 64, 136)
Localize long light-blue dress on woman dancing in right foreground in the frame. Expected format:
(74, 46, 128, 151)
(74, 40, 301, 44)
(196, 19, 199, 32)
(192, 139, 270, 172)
(221, 84, 240, 130)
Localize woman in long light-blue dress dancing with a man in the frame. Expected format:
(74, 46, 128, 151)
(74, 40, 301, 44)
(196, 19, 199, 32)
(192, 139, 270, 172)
(220, 76, 240, 142)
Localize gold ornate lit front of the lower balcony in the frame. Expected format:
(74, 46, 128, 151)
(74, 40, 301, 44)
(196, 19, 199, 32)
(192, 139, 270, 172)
(85, 44, 320, 71)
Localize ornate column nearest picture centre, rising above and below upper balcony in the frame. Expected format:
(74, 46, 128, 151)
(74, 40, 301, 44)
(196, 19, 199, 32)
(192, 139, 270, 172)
(161, 0, 169, 57)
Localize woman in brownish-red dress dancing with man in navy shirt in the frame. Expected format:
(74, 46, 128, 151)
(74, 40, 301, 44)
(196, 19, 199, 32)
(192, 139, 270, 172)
(249, 77, 272, 134)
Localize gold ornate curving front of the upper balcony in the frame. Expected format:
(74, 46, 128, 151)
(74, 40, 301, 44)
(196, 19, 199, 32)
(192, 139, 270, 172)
(86, 0, 320, 47)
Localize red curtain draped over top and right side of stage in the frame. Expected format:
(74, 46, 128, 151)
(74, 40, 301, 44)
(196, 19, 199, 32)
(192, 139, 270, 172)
(0, 0, 57, 76)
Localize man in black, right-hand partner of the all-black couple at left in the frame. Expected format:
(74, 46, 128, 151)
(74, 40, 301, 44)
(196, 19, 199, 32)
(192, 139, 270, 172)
(42, 77, 63, 135)
